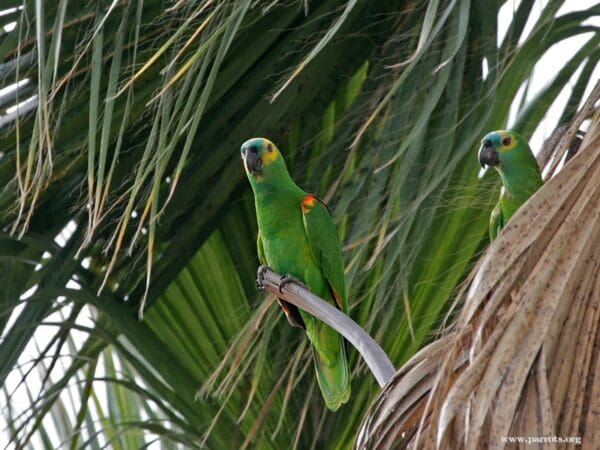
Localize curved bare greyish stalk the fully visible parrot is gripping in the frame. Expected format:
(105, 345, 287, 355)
(258, 266, 396, 387)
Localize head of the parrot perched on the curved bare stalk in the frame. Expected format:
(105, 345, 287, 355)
(240, 138, 289, 183)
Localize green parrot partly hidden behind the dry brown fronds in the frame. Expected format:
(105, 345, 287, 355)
(479, 130, 543, 240)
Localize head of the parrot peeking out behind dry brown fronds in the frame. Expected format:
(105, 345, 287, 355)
(478, 130, 535, 172)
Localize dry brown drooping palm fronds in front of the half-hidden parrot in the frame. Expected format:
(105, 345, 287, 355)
(356, 87, 600, 450)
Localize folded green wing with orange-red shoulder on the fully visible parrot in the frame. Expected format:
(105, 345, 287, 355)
(301, 195, 348, 313)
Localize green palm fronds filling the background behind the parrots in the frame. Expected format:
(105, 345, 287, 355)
(0, 0, 600, 449)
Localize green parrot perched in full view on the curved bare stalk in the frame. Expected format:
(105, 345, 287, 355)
(241, 138, 350, 411)
